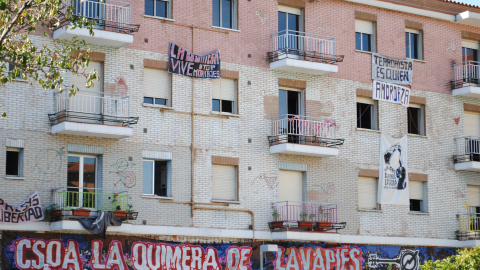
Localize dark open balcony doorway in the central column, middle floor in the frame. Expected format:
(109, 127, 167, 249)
(277, 89, 304, 143)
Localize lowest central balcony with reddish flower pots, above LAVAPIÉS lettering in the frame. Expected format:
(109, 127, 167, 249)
(269, 201, 346, 232)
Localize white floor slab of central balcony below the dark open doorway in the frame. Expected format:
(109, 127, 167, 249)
(270, 143, 339, 157)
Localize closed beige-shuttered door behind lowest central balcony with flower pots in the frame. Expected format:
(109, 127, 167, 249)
(279, 170, 304, 220)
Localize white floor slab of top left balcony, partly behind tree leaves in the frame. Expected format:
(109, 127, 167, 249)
(53, 27, 133, 48)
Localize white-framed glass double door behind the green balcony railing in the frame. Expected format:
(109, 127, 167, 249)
(64, 155, 98, 208)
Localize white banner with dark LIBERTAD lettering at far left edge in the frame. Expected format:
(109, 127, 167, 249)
(0, 191, 43, 224)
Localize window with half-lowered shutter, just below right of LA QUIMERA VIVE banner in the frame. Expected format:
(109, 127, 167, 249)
(212, 79, 237, 113)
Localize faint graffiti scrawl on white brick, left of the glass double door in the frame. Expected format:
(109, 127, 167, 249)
(34, 147, 63, 182)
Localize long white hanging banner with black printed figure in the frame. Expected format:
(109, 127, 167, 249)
(377, 134, 410, 205)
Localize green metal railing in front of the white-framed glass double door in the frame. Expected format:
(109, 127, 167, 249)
(53, 187, 128, 211)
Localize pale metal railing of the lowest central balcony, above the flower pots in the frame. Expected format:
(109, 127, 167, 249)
(272, 201, 337, 223)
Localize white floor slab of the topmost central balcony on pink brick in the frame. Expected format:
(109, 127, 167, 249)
(270, 58, 338, 76)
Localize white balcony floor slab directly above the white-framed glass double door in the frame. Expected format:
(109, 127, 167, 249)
(52, 122, 133, 139)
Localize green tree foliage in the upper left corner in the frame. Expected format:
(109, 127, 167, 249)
(0, 0, 97, 118)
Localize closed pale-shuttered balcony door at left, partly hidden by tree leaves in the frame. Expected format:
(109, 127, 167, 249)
(68, 61, 105, 124)
